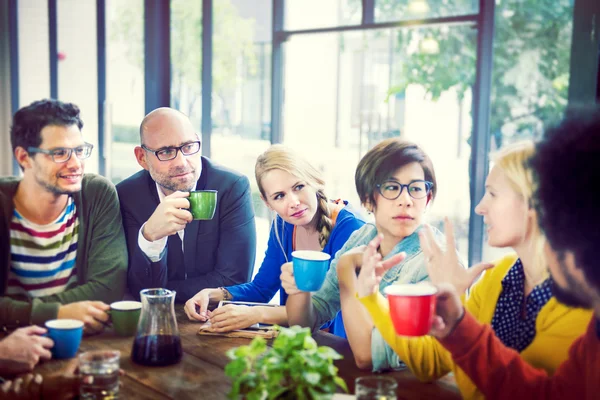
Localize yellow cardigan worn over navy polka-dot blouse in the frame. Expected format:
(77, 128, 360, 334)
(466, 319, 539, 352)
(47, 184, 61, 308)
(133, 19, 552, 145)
(360, 255, 592, 399)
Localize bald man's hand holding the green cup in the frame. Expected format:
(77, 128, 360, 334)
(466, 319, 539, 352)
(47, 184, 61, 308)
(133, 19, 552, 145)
(142, 192, 194, 242)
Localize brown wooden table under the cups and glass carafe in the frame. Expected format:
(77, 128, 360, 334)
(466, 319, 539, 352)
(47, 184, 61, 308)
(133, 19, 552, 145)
(35, 305, 460, 400)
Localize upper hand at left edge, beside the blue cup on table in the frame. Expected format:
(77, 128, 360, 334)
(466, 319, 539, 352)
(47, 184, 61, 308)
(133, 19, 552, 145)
(0, 326, 54, 376)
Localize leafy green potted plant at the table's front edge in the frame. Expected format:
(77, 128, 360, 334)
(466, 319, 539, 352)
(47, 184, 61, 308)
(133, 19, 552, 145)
(225, 326, 348, 400)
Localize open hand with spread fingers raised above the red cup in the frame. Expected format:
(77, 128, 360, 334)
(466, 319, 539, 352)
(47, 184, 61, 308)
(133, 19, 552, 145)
(419, 218, 494, 295)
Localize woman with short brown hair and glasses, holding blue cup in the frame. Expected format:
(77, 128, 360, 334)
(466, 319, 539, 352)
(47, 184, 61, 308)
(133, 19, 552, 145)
(281, 138, 442, 370)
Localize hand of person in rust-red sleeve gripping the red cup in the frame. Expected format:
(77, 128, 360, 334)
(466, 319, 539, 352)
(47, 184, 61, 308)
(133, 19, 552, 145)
(429, 283, 465, 339)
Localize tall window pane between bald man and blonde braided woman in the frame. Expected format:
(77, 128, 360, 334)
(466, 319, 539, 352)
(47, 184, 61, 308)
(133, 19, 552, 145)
(211, 0, 279, 288)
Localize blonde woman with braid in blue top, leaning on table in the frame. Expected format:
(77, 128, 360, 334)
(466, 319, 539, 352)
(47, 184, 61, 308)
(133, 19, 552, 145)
(185, 145, 364, 337)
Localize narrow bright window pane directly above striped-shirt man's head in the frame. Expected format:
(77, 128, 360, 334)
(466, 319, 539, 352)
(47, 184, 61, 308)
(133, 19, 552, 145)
(56, 0, 99, 173)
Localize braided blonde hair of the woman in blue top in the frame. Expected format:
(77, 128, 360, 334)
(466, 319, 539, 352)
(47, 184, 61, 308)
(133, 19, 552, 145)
(254, 144, 333, 260)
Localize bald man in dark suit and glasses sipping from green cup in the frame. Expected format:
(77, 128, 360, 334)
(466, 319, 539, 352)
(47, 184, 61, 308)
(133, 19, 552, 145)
(117, 108, 256, 302)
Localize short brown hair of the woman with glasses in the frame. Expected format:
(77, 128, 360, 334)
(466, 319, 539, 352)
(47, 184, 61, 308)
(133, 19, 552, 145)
(354, 138, 437, 205)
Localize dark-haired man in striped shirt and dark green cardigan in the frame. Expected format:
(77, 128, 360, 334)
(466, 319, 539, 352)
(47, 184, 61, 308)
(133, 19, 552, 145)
(0, 100, 127, 332)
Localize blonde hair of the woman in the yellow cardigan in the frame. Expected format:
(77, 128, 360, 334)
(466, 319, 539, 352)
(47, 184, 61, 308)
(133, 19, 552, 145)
(492, 140, 548, 277)
